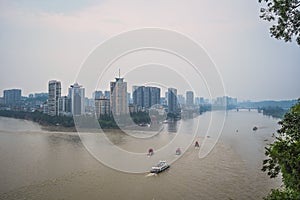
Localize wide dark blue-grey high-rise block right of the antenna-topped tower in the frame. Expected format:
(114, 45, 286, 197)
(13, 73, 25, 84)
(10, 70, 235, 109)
(132, 86, 160, 108)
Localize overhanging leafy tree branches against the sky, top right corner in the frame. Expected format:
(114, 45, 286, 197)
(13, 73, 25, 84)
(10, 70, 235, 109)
(258, 0, 300, 46)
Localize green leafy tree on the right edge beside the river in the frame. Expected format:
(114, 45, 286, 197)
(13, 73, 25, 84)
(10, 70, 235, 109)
(262, 99, 300, 199)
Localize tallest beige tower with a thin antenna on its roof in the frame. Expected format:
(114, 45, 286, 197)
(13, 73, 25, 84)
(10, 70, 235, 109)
(110, 78, 128, 115)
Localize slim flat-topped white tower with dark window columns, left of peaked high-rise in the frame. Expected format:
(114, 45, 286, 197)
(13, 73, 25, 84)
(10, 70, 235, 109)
(48, 80, 61, 116)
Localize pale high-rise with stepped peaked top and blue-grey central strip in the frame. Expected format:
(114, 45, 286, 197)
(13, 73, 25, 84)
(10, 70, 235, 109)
(69, 83, 85, 115)
